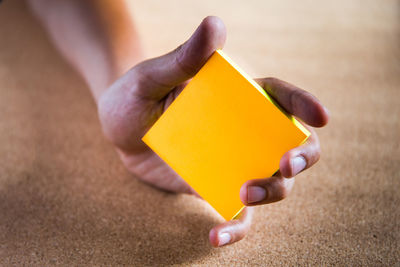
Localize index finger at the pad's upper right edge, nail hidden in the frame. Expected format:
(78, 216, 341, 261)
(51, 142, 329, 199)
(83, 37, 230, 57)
(257, 78, 329, 127)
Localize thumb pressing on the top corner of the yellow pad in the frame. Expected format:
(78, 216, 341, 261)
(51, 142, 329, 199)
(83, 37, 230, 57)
(130, 16, 226, 100)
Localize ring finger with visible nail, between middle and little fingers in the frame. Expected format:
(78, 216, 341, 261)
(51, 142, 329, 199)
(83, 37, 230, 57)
(240, 175, 294, 206)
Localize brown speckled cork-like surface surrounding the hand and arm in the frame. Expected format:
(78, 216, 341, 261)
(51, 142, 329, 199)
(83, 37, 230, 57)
(0, 0, 400, 266)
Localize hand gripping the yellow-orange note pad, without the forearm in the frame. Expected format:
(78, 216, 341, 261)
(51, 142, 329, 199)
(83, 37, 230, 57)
(98, 17, 328, 246)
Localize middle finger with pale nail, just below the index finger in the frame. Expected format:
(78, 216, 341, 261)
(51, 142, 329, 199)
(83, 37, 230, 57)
(279, 127, 321, 180)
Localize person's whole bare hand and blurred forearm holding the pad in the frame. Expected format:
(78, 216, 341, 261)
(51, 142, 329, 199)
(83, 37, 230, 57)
(28, 0, 329, 247)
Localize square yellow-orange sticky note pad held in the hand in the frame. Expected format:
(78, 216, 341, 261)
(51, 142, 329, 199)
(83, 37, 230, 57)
(142, 50, 310, 220)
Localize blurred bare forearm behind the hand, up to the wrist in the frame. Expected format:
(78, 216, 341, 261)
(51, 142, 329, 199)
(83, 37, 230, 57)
(27, 0, 142, 102)
